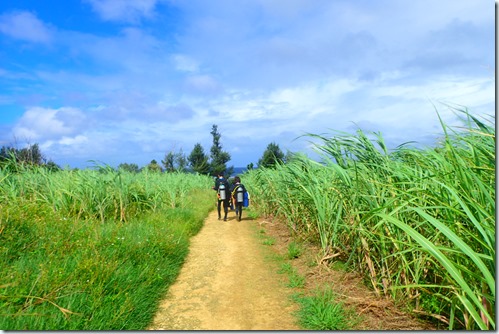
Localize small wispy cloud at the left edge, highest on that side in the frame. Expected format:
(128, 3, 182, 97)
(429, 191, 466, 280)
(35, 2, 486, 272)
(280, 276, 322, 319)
(0, 12, 52, 44)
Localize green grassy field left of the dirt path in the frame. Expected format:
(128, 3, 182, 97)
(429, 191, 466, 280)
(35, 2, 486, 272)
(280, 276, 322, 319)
(0, 165, 213, 330)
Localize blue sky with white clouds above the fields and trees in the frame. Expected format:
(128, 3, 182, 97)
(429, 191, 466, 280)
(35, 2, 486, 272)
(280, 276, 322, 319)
(0, 0, 496, 168)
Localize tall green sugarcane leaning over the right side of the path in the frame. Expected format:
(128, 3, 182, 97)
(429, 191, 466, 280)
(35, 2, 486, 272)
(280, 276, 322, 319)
(245, 110, 495, 329)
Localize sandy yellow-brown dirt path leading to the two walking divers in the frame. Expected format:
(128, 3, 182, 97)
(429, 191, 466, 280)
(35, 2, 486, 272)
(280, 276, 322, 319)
(149, 211, 299, 330)
